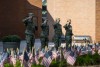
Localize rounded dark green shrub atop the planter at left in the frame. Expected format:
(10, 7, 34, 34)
(2, 35, 21, 42)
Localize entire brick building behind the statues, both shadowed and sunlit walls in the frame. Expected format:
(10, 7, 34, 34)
(0, 0, 100, 42)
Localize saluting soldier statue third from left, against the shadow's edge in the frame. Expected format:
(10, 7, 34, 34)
(53, 18, 62, 50)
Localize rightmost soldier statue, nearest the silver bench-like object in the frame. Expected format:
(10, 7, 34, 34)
(64, 19, 73, 50)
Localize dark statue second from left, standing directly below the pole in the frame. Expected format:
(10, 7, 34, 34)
(40, 19, 49, 48)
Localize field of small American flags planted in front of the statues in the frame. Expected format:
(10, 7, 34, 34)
(0, 45, 100, 67)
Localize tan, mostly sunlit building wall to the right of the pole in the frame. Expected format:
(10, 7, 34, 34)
(47, 0, 100, 42)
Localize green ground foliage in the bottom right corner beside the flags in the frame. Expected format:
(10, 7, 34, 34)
(75, 53, 100, 66)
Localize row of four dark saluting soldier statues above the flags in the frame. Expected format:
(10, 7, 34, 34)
(23, 13, 73, 52)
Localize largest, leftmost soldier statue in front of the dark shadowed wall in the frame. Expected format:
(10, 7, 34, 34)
(23, 13, 37, 52)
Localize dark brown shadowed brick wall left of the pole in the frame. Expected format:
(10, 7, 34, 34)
(0, 0, 42, 39)
